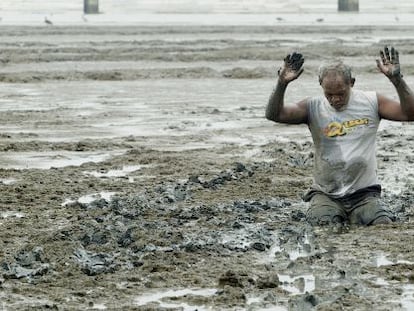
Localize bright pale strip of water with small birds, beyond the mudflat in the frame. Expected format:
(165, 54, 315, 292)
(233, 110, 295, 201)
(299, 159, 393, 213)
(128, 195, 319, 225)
(0, 11, 414, 27)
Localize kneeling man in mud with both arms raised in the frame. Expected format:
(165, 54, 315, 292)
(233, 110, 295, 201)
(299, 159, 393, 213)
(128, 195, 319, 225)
(266, 47, 414, 225)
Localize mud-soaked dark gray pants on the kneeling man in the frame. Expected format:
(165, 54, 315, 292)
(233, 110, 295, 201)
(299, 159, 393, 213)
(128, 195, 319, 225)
(306, 192, 395, 225)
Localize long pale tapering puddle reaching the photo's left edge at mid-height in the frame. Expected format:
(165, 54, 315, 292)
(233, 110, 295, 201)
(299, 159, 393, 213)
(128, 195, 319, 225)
(0, 151, 123, 169)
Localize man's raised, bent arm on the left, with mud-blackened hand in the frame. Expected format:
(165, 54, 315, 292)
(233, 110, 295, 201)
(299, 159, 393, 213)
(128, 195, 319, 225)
(266, 53, 307, 124)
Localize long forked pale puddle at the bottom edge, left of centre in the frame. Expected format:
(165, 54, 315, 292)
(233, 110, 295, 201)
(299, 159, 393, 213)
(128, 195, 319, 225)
(134, 288, 217, 311)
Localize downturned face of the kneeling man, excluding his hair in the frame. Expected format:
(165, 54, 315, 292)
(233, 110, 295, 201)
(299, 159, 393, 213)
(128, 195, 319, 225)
(321, 72, 353, 111)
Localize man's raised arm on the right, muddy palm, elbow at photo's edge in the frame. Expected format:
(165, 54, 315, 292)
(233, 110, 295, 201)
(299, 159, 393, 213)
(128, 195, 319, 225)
(376, 47, 414, 121)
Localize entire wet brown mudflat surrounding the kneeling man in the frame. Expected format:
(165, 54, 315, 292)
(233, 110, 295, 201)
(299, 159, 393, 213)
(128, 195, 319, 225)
(0, 25, 414, 311)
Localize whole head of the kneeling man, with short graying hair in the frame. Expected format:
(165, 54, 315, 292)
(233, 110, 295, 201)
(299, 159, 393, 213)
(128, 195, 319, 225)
(319, 62, 355, 111)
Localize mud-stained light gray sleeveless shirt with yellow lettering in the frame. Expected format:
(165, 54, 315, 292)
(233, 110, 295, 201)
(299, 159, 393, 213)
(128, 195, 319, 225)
(308, 89, 380, 198)
